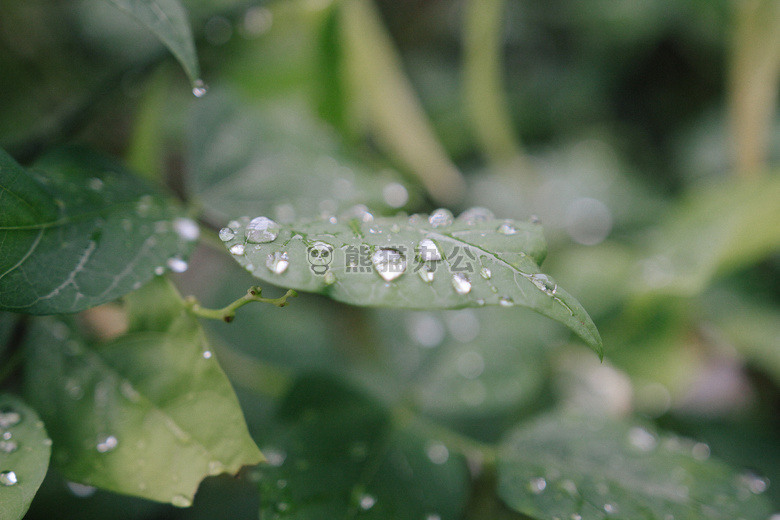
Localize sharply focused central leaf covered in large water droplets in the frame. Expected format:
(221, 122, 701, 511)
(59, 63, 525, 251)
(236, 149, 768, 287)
(220, 207, 602, 355)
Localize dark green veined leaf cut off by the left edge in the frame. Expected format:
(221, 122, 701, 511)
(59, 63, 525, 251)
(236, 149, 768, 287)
(0, 149, 199, 314)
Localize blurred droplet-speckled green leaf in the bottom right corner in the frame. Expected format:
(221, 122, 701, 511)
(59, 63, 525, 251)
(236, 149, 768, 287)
(498, 414, 770, 520)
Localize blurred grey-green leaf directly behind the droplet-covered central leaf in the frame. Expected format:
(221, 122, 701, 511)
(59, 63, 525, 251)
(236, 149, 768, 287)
(189, 89, 410, 222)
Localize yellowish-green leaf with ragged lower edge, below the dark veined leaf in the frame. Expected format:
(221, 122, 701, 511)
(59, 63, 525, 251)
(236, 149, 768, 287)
(26, 279, 263, 506)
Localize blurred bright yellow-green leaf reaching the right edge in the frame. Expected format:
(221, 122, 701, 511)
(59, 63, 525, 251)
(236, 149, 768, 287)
(635, 175, 780, 296)
